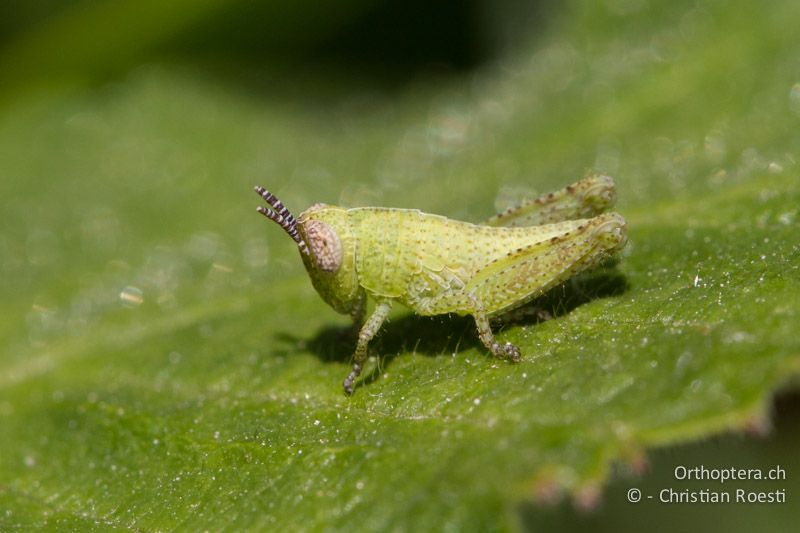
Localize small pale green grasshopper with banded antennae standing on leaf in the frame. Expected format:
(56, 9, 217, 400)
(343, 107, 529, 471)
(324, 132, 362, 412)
(255, 175, 627, 395)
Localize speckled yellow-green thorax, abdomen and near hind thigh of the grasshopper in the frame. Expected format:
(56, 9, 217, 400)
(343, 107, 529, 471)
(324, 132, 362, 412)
(348, 208, 613, 316)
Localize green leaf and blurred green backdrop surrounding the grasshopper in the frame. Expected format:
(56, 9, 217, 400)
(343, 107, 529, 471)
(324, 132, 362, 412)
(0, 0, 800, 531)
